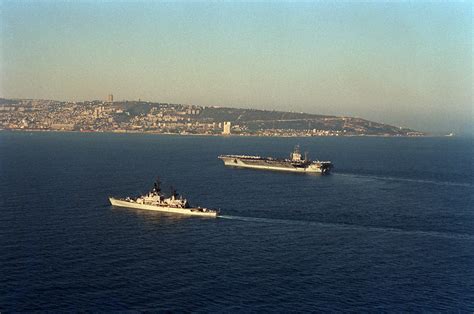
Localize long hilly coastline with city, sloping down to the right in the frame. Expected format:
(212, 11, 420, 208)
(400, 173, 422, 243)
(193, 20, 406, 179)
(0, 98, 426, 136)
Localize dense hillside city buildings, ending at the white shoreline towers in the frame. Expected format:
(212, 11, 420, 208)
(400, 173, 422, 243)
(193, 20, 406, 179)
(0, 95, 239, 135)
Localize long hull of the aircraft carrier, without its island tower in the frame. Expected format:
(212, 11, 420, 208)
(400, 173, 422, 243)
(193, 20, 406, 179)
(220, 157, 329, 173)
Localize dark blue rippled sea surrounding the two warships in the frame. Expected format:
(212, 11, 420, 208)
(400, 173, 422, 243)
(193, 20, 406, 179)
(0, 132, 474, 312)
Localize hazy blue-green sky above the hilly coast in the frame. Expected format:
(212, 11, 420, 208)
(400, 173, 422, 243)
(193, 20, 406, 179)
(0, 0, 474, 132)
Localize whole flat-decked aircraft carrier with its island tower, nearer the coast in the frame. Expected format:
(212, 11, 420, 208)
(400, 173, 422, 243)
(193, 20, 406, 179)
(218, 146, 333, 174)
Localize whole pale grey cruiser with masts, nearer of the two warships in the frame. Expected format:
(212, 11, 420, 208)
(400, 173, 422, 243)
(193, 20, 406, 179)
(109, 180, 218, 217)
